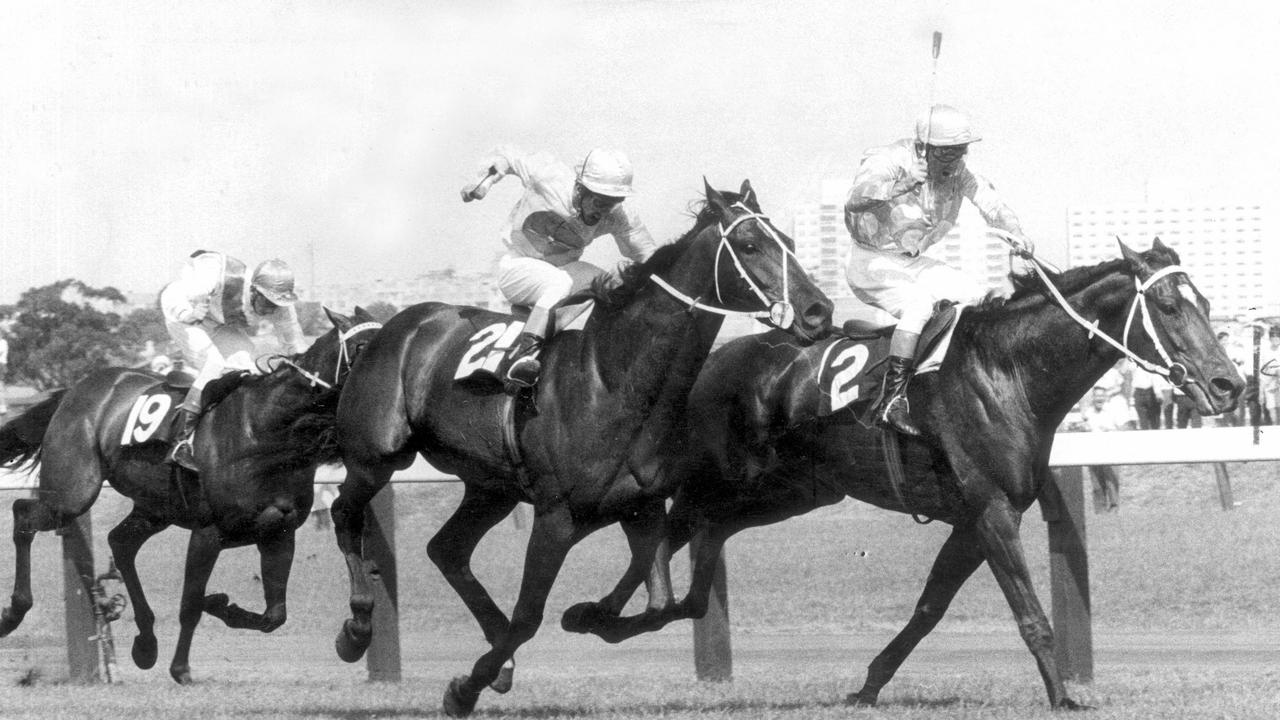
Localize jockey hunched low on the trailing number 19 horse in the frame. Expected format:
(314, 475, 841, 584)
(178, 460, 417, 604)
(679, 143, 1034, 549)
(160, 250, 305, 470)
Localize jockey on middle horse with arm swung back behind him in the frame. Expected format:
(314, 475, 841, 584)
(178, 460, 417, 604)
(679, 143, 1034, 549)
(462, 147, 657, 387)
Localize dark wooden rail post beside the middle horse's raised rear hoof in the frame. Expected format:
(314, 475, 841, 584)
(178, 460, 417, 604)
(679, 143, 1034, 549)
(365, 484, 401, 683)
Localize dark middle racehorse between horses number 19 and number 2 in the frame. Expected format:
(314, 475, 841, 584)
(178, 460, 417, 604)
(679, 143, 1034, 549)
(332, 182, 832, 715)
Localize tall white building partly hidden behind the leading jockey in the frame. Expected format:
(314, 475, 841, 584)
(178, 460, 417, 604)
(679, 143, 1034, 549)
(791, 179, 1021, 297)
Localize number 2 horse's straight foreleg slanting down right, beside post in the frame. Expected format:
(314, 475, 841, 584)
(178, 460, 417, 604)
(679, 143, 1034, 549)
(975, 498, 1085, 710)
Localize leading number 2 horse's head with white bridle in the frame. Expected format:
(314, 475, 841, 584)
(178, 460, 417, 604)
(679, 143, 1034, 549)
(1117, 237, 1244, 415)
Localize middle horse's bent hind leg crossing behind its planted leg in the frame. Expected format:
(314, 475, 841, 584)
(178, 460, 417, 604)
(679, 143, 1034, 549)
(426, 486, 517, 693)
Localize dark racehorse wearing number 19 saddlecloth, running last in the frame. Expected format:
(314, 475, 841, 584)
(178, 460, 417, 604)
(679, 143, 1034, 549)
(0, 307, 379, 684)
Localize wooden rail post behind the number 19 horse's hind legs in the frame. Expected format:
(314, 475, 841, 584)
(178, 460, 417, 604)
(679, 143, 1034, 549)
(59, 512, 102, 683)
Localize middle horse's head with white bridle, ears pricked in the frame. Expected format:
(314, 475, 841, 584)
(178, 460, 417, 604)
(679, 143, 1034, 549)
(668, 181, 832, 343)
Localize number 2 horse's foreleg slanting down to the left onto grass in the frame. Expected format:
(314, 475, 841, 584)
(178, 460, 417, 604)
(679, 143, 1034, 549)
(846, 528, 983, 705)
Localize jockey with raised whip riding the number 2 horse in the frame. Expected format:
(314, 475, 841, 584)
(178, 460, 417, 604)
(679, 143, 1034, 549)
(845, 105, 1032, 434)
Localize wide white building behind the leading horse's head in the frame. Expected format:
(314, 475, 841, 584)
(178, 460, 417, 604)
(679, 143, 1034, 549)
(1066, 204, 1280, 319)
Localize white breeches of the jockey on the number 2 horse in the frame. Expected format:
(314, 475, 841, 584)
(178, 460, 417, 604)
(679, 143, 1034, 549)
(845, 242, 987, 333)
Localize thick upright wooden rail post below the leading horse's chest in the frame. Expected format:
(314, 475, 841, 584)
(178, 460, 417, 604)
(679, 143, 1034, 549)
(1041, 466, 1093, 683)
